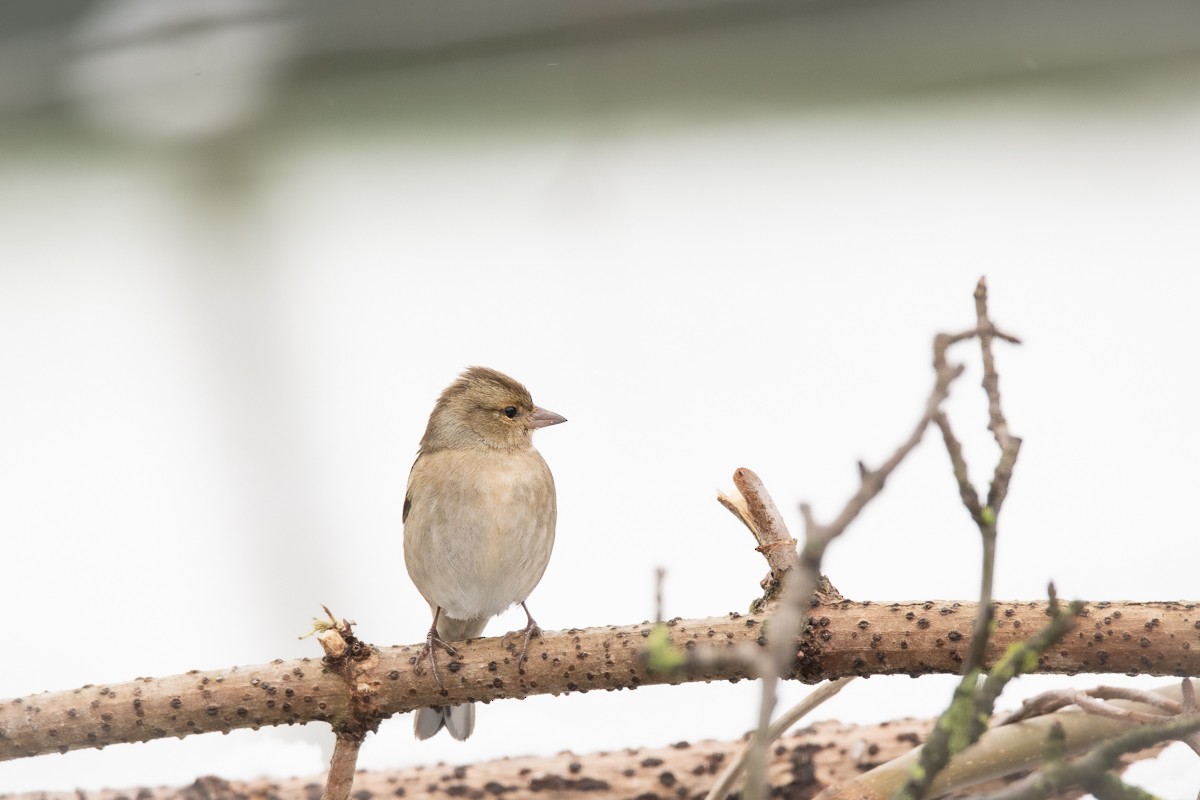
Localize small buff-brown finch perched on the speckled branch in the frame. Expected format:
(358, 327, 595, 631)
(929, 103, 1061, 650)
(403, 367, 566, 740)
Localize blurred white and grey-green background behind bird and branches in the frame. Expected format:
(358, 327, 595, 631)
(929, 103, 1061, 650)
(0, 0, 1200, 799)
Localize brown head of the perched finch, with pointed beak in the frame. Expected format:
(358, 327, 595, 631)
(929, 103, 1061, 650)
(421, 367, 566, 452)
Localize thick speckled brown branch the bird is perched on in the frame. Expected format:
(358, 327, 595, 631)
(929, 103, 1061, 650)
(0, 601, 1200, 760)
